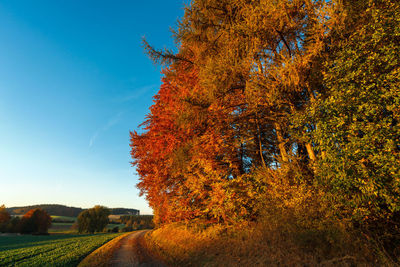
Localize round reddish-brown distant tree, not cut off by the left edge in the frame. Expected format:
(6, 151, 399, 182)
(20, 209, 51, 234)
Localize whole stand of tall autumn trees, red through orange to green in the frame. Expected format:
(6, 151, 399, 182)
(130, 0, 400, 258)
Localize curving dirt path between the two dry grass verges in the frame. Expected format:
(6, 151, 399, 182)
(110, 230, 165, 267)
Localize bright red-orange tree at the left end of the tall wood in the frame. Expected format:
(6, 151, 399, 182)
(131, 57, 202, 223)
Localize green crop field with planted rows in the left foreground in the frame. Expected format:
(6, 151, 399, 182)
(0, 233, 120, 266)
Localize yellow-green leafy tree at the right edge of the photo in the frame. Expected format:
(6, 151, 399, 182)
(304, 1, 400, 223)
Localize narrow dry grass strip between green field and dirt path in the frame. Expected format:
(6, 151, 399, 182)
(78, 232, 131, 267)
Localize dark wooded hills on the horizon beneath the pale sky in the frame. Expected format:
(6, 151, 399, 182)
(7, 204, 140, 217)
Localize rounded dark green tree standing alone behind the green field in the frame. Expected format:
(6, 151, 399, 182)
(77, 205, 110, 234)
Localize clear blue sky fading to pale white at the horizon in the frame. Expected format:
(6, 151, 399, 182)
(0, 0, 187, 214)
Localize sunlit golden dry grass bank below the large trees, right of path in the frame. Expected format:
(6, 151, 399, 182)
(146, 221, 390, 266)
